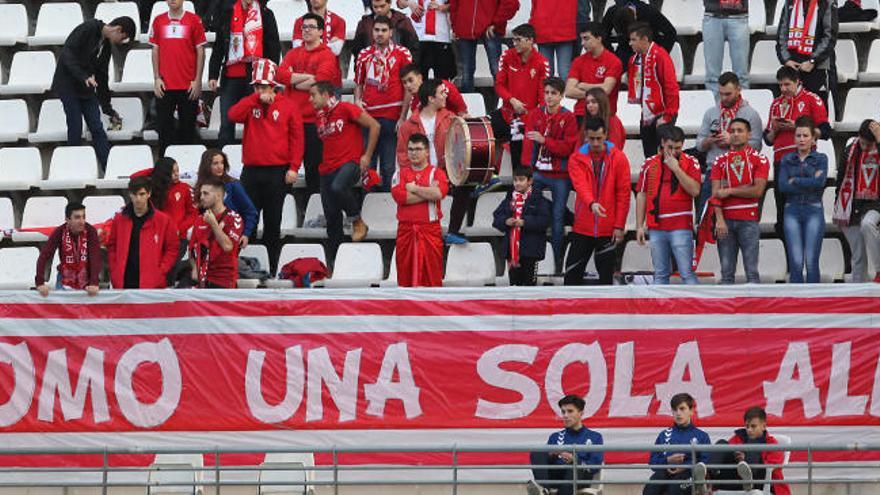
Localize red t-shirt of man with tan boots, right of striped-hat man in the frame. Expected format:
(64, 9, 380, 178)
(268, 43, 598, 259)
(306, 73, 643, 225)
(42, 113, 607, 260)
(316, 100, 364, 175)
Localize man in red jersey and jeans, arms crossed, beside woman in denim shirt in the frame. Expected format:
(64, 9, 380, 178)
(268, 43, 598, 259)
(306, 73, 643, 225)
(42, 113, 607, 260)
(710, 117, 770, 284)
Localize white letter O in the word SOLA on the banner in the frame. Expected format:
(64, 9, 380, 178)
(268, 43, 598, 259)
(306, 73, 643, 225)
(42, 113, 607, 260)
(544, 342, 608, 418)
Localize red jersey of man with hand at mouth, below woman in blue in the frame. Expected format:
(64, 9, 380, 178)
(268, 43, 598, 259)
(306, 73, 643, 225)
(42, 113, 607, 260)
(189, 208, 244, 289)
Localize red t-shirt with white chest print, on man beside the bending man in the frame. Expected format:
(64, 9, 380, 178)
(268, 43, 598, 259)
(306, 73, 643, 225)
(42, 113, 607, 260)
(150, 11, 207, 91)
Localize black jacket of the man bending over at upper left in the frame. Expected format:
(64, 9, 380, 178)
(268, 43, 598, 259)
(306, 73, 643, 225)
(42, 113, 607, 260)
(52, 19, 116, 115)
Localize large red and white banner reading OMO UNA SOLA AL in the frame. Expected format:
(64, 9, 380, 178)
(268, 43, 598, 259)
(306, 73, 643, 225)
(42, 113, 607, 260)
(0, 284, 880, 470)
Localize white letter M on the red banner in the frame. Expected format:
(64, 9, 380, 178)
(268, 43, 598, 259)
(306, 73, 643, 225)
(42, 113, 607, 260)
(37, 347, 110, 423)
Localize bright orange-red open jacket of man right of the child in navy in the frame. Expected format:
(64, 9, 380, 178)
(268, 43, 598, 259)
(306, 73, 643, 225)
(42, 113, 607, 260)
(568, 144, 632, 237)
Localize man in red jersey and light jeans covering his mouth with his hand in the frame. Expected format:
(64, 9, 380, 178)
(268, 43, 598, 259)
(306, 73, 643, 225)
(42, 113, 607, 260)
(636, 125, 700, 285)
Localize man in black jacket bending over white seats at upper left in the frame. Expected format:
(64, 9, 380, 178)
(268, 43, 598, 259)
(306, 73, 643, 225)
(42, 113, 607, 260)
(52, 17, 135, 167)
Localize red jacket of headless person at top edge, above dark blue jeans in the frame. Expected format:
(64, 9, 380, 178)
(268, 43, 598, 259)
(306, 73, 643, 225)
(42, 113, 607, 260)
(449, 0, 519, 40)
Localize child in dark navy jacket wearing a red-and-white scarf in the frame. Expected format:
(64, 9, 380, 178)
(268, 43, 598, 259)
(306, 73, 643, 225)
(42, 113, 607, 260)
(492, 167, 550, 286)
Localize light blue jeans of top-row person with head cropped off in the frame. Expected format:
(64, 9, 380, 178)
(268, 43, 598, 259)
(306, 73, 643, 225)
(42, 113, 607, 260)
(703, 15, 749, 100)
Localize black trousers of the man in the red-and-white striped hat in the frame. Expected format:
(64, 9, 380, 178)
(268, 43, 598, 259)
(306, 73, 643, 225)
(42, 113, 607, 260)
(241, 164, 290, 276)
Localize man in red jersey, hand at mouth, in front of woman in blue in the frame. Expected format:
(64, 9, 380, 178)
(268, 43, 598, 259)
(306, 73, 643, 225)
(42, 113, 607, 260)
(189, 176, 244, 289)
